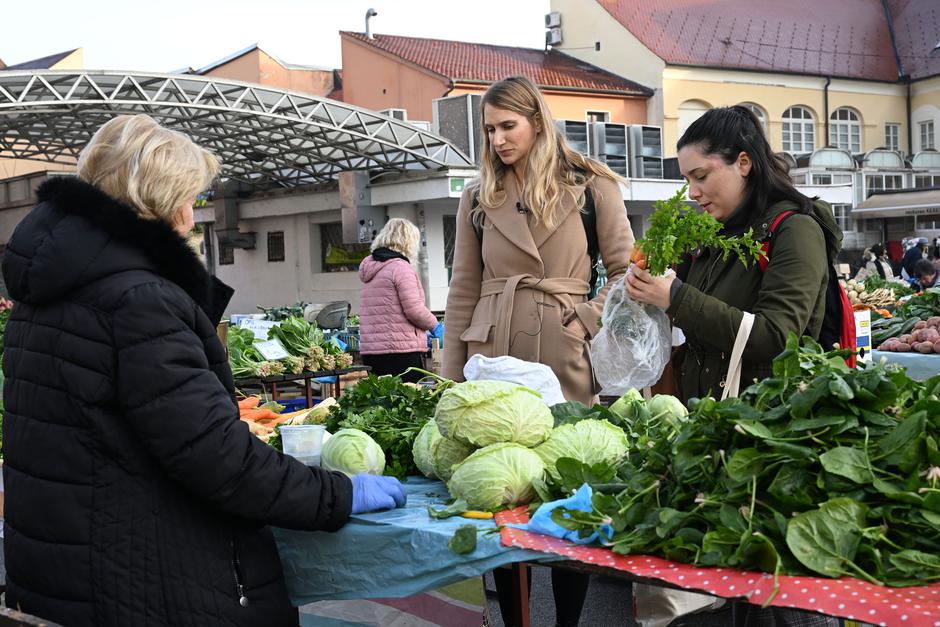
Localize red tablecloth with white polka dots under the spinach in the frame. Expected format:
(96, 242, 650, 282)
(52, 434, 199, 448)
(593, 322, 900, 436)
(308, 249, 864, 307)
(496, 507, 940, 627)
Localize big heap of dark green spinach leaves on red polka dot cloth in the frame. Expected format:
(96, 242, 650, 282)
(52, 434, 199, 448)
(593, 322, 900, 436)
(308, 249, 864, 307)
(553, 335, 940, 586)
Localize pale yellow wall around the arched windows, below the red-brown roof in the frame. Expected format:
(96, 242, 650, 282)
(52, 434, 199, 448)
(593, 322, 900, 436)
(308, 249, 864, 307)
(663, 66, 912, 157)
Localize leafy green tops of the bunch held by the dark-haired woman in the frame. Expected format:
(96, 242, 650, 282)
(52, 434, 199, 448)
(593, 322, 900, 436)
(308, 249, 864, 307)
(636, 185, 764, 276)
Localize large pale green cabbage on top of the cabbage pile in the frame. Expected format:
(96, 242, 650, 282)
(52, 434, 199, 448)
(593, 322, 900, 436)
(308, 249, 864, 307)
(434, 381, 555, 447)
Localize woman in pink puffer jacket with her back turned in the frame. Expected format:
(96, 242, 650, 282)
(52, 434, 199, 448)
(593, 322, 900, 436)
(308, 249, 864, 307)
(359, 218, 437, 381)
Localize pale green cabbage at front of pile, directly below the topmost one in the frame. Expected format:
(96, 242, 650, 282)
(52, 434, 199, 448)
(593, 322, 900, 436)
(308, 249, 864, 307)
(447, 442, 545, 511)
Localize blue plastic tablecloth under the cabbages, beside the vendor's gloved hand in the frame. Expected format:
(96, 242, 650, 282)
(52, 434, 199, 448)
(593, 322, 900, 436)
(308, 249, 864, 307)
(274, 477, 562, 606)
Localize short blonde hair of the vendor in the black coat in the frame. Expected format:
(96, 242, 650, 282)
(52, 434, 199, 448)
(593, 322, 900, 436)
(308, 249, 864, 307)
(78, 114, 219, 224)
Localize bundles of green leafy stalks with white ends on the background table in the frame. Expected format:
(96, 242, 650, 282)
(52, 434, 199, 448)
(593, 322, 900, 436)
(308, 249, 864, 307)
(227, 316, 353, 379)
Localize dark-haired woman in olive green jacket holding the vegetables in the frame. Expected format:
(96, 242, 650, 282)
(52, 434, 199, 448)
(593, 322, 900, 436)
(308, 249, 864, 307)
(629, 106, 842, 401)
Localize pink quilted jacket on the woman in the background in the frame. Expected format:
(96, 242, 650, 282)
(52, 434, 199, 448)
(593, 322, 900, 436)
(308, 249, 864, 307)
(359, 255, 437, 355)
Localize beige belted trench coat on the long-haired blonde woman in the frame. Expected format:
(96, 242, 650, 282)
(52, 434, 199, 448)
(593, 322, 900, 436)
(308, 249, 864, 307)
(442, 176, 633, 404)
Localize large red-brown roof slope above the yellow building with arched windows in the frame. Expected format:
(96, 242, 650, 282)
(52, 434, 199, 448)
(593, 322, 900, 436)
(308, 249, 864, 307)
(597, 0, 900, 81)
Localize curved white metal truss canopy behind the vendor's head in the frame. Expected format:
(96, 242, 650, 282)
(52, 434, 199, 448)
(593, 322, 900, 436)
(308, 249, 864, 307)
(0, 70, 473, 189)
